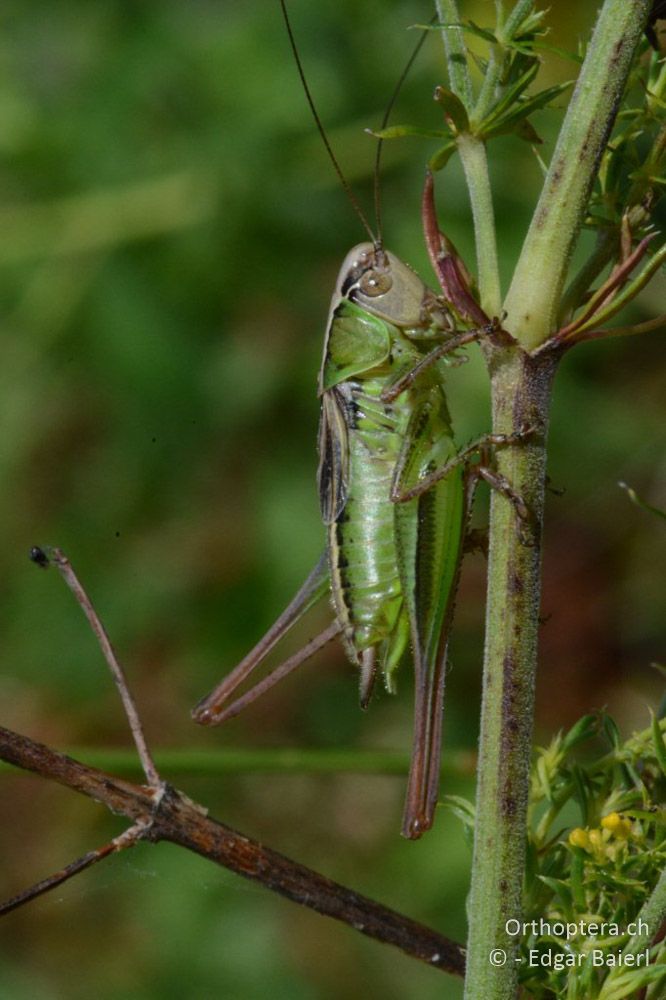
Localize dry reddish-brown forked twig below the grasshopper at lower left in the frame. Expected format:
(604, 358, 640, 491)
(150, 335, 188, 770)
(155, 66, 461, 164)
(0, 548, 465, 976)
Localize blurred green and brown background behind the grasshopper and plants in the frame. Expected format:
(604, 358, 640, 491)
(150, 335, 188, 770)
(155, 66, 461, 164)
(0, 0, 666, 1000)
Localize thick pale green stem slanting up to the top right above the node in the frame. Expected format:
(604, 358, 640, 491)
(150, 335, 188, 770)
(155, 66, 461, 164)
(504, 0, 651, 350)
